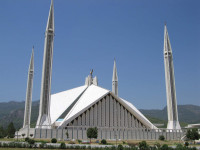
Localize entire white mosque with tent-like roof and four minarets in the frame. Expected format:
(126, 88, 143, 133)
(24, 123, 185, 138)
(18, 0, 182, 139)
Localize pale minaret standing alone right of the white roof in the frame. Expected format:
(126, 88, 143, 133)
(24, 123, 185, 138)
(164, 25, 181, 129)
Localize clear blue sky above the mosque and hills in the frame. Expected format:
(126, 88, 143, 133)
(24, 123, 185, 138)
(0, 0, 200, 109)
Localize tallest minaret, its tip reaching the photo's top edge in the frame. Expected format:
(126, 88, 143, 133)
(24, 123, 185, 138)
(36, 0, 54, 128)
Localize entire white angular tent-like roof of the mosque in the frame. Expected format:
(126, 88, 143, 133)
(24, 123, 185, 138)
(50, 84, 156, 129)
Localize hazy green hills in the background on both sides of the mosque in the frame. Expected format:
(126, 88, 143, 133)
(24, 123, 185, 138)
(0, 101, 200, 129)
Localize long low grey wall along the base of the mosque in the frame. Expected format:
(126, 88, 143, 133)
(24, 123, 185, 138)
(34, 126, 186, 140)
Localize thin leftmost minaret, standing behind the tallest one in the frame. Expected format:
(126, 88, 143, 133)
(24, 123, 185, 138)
(23, 47, 34, 137)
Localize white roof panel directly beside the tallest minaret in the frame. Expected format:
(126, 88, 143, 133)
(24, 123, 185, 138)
(50, 85, 87, 124)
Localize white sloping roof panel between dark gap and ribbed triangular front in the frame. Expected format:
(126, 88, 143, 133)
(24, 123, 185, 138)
(61, 84, 109, 125)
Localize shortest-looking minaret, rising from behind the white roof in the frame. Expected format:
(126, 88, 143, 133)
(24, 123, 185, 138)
(112, 59, 118, 96)
